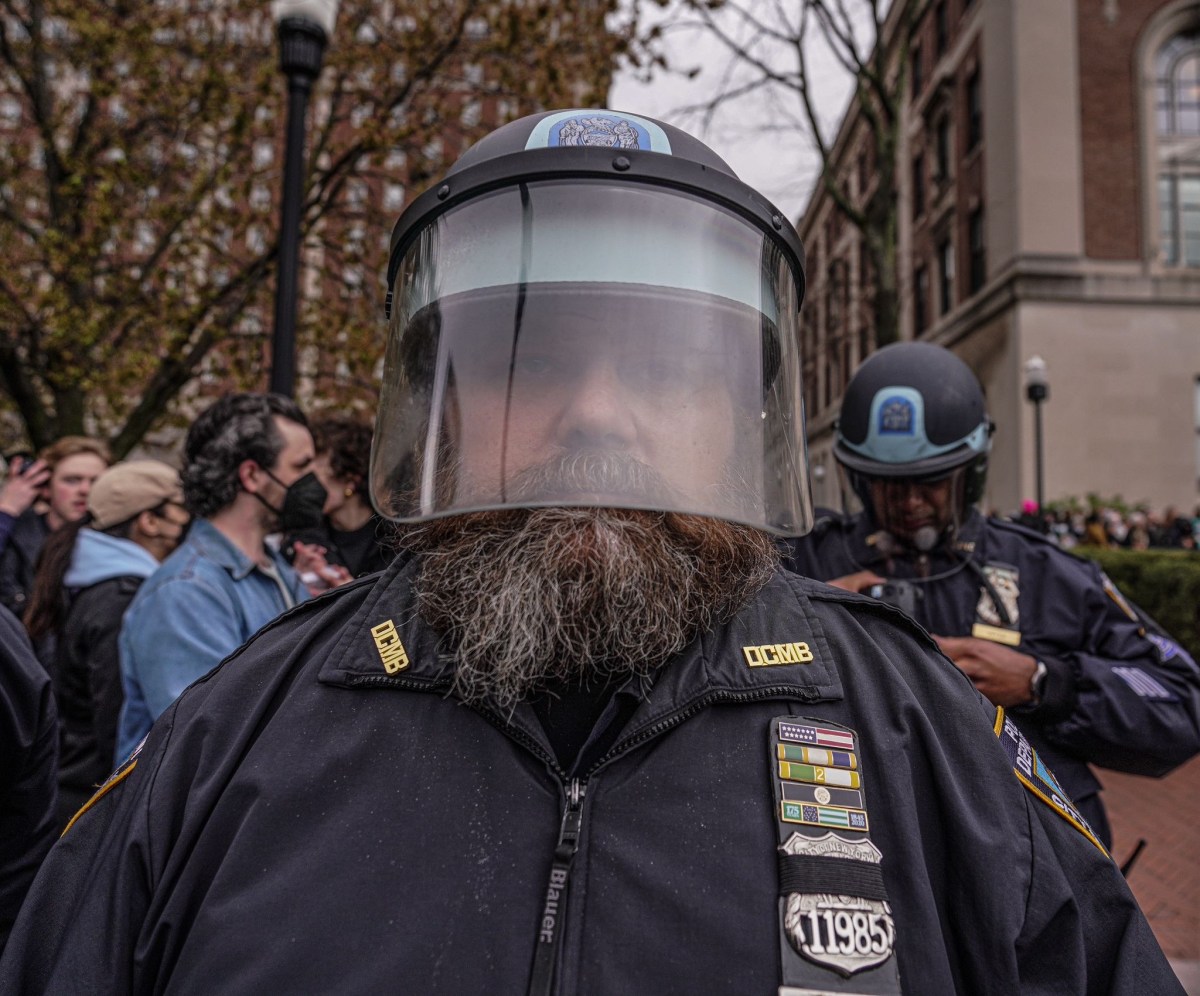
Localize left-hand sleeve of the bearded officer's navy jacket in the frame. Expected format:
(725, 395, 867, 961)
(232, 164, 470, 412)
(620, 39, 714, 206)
(0, 586, 350, 996)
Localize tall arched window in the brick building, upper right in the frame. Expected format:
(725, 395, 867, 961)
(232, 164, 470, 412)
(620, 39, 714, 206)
(1153, 20, 1200, 268)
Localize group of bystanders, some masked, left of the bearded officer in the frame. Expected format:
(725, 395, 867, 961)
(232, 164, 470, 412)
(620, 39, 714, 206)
(0, 405, 392, 873)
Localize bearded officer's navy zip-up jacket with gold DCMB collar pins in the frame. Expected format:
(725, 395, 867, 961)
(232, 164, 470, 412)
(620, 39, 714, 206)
(0, 557, 1182, 996)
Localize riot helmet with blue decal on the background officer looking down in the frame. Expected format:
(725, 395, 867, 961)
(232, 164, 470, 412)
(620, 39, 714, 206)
(834, 342, 992, 552)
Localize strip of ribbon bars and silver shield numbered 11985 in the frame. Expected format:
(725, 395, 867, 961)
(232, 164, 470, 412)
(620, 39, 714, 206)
(770, 716, 900, 996)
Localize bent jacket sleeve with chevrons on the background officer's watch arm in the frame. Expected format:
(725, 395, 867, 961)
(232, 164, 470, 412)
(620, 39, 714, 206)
(1020, 554, 1200, 775)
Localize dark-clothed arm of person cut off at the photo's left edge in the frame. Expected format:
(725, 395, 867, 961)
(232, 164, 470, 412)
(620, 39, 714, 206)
(0, 607, 59, 954)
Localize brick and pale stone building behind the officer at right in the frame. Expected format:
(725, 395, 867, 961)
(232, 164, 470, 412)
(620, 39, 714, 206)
(800, 0, 1200, 511)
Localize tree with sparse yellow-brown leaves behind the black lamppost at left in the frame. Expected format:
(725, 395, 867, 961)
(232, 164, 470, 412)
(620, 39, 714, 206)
(0, 0, 632, 455)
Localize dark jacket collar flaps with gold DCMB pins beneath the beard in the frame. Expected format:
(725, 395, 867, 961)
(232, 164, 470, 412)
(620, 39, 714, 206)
(319, 556, 842, 740)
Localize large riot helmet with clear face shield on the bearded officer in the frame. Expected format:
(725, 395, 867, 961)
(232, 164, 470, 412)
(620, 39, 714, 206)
(371, 110, 812, 535)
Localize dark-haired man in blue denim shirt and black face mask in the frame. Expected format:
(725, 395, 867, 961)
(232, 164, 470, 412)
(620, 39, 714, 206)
(114, 394, 325, 762)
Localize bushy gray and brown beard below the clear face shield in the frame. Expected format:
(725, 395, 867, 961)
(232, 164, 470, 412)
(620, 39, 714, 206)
(403, 508, 778, 710)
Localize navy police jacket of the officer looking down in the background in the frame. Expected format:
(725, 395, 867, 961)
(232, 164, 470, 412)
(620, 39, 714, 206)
(784, 510, 1200, 845)
